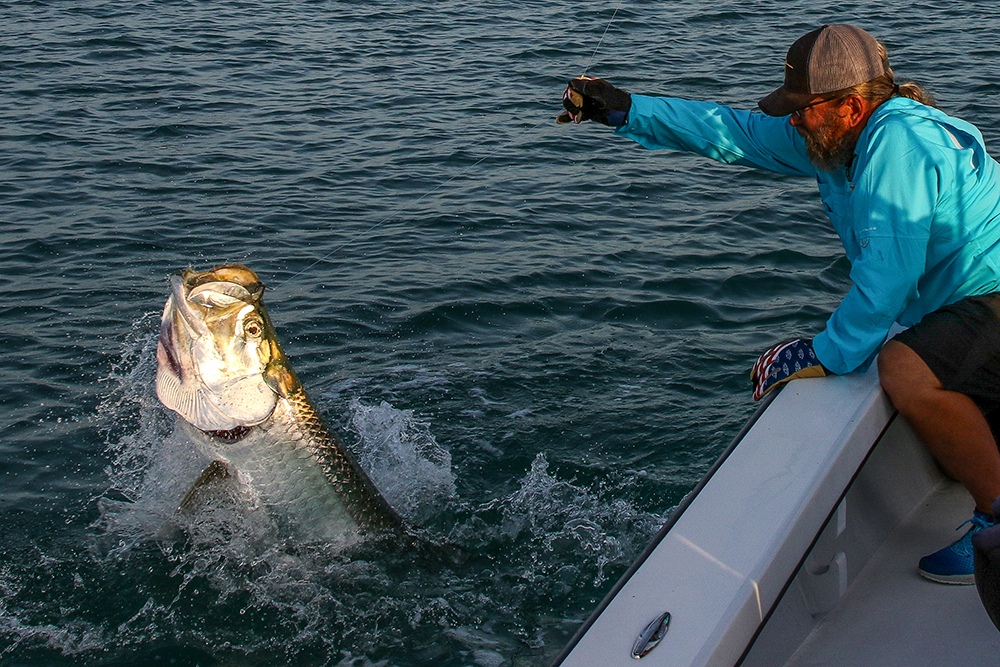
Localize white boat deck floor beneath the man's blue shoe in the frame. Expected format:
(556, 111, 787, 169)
(785, 482, 1000, 667)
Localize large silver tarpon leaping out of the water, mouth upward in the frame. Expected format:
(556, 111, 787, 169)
(156, 265, 403, 538)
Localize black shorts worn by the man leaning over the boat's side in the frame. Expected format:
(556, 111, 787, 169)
(893, 292, 1000, 414)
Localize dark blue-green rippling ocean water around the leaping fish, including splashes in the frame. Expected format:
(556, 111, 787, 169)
(0, 0, 1000, 667)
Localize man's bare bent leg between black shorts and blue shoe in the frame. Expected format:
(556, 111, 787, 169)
(878, 340, 1000, 514)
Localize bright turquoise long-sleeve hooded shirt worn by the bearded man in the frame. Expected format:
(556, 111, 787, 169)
(617, 95, 1000, 373)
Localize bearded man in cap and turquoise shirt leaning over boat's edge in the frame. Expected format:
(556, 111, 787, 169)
(559, 25, 1000, 584)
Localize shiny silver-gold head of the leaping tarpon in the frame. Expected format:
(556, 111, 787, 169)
(156, 265, 294, 431)
